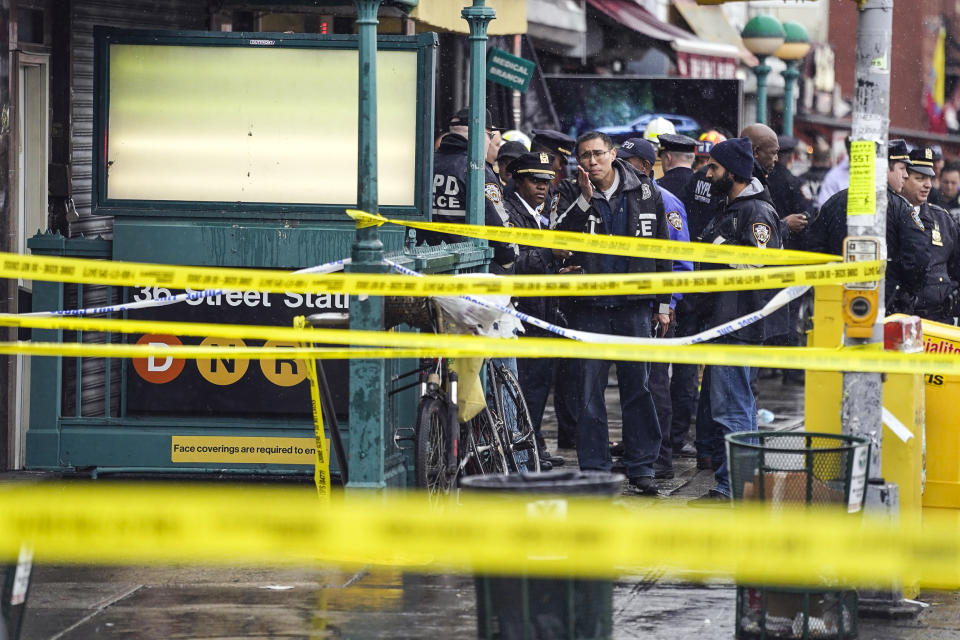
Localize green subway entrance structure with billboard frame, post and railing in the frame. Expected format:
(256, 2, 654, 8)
(27, 7, 491, 489)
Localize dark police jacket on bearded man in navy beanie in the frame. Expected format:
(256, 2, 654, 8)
(698, 178, 787, 343)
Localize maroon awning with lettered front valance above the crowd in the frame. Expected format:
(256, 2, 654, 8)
(587, 0, 740, 77)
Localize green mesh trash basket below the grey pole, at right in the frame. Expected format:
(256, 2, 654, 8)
(726, 431, 870, 640)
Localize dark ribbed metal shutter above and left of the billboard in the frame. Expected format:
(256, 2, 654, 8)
(70, 0, 210, 238)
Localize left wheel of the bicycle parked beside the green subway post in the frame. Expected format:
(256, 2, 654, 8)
(414, 397, 457, 502)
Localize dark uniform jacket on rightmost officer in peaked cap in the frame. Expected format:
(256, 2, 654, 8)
(916, 203, 960, 322)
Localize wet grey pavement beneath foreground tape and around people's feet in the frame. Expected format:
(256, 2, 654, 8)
(11, 378, 960, 640)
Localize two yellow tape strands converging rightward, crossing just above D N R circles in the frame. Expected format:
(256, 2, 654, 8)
(0, 314, 960, 375)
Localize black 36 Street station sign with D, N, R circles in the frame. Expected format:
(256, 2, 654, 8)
(127, 287, 348, 417)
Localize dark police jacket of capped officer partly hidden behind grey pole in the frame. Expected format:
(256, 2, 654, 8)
(804, 189, 930, 313)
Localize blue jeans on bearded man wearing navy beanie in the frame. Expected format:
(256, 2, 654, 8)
(697, 365, 757, 496)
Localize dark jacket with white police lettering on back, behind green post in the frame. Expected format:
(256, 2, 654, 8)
(417, 133, 516, 273)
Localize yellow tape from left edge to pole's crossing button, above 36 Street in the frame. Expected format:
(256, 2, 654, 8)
(0, 247, 886, 296)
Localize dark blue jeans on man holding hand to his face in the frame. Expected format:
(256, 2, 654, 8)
(570, 302, 660, 478)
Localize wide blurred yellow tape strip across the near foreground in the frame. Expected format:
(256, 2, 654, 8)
(0, 482, 960, 588)
